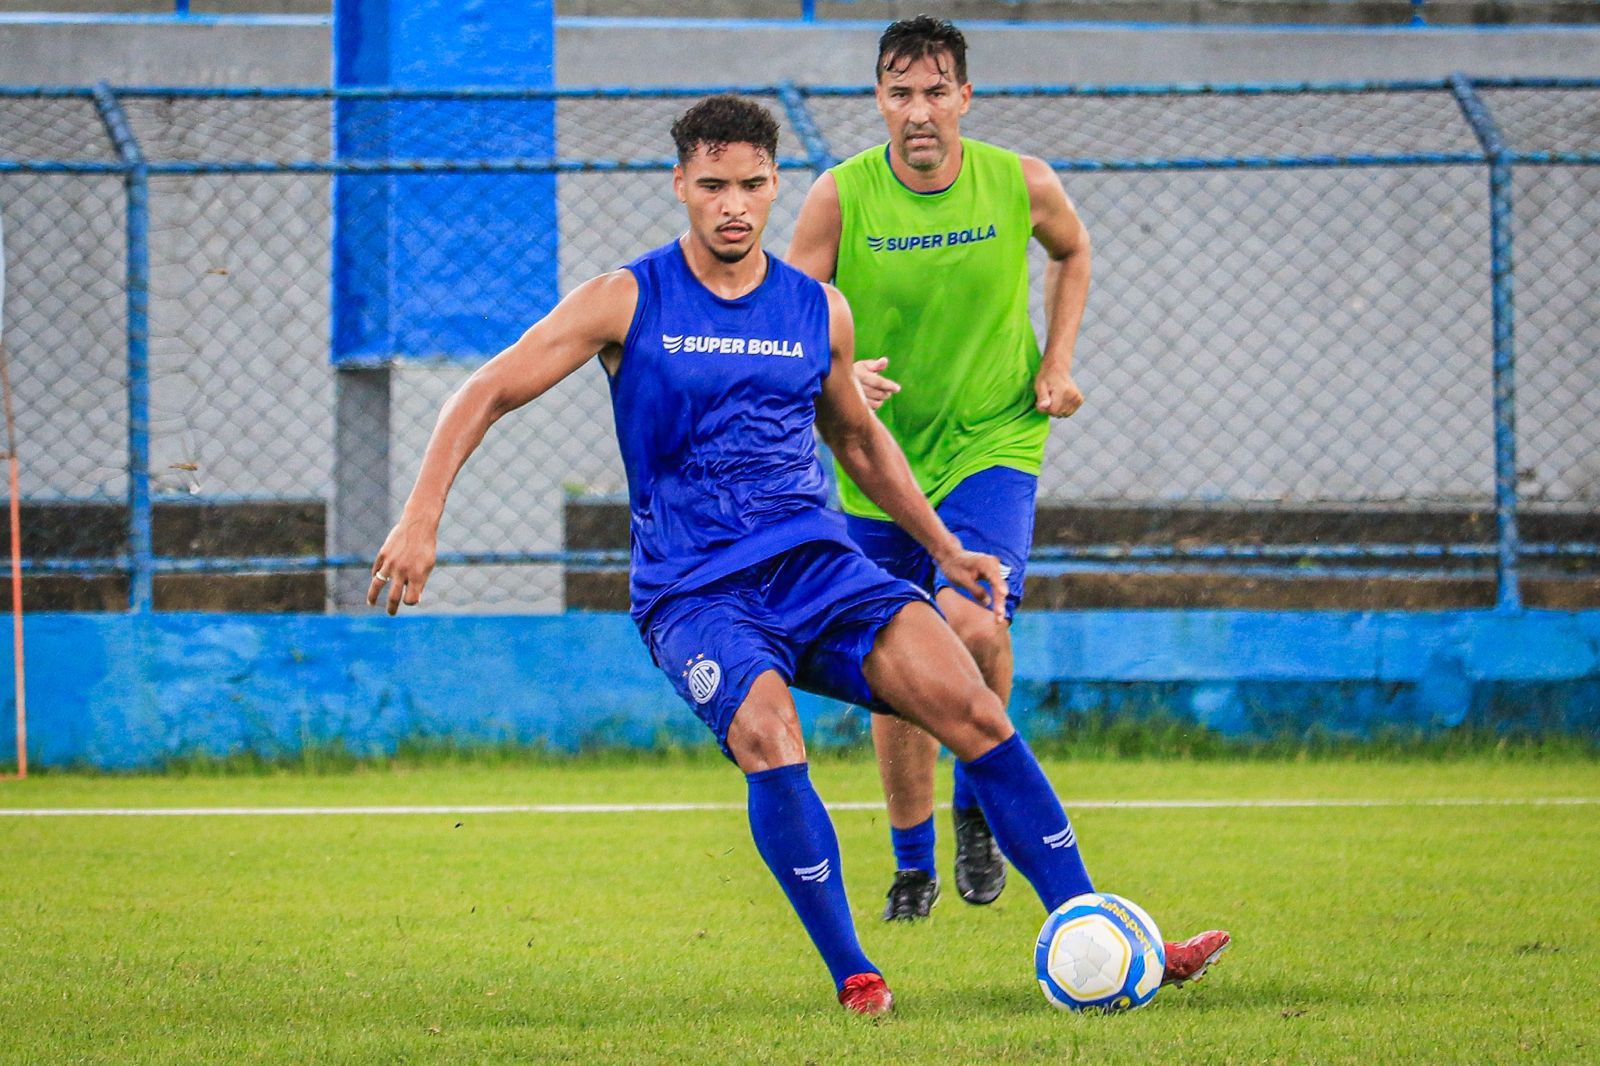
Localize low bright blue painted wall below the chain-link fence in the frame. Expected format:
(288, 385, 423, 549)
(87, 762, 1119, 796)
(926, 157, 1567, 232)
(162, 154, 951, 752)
(9, 611, 1600, 768)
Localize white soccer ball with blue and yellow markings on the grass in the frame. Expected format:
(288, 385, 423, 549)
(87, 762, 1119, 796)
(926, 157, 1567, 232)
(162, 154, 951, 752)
(1034, 892, 1166, 1010)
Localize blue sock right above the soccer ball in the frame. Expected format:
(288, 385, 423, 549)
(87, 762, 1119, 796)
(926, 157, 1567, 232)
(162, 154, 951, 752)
(966, 733, 1094, 911)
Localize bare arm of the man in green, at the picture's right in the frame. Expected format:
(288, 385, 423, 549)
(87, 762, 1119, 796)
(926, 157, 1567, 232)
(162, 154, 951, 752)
(1022, 155, 1090, 418)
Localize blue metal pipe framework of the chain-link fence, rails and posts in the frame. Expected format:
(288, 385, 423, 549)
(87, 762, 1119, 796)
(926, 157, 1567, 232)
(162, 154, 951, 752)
(0, 75, 1600, 610)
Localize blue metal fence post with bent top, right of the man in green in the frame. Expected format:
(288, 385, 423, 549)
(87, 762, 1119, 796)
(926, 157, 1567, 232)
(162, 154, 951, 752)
(1450, 74, 1522, 611)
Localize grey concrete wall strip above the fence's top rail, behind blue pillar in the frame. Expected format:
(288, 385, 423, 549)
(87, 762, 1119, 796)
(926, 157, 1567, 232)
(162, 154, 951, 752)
(0, 16, 1600, 85)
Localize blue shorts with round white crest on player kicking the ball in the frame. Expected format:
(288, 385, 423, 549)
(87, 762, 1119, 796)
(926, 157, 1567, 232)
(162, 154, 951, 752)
(645, 541, 938, 759)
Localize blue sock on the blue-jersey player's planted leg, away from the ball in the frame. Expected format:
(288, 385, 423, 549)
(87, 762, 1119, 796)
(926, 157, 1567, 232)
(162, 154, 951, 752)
(744, 762, 878, 989)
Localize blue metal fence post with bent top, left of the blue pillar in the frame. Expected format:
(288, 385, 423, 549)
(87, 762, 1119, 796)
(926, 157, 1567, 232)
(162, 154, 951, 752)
(94, 82, 155, 611)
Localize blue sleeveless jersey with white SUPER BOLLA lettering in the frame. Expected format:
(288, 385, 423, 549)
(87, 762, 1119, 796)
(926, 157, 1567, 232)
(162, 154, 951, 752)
(611, 240, 850, 627)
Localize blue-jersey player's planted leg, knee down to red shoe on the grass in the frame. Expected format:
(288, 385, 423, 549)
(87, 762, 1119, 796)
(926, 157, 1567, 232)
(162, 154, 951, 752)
(726, 671, 894, 1015)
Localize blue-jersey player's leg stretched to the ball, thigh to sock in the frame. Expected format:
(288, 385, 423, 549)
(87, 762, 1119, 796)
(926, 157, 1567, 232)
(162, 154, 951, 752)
(862, 603, 1093, 911)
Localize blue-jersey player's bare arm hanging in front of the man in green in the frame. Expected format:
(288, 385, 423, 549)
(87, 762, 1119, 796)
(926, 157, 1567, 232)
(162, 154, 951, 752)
(816, 285, 1005, 624)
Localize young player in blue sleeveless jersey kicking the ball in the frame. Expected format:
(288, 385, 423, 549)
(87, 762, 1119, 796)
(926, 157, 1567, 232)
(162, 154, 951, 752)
(368, 96, 1222, 1015)
